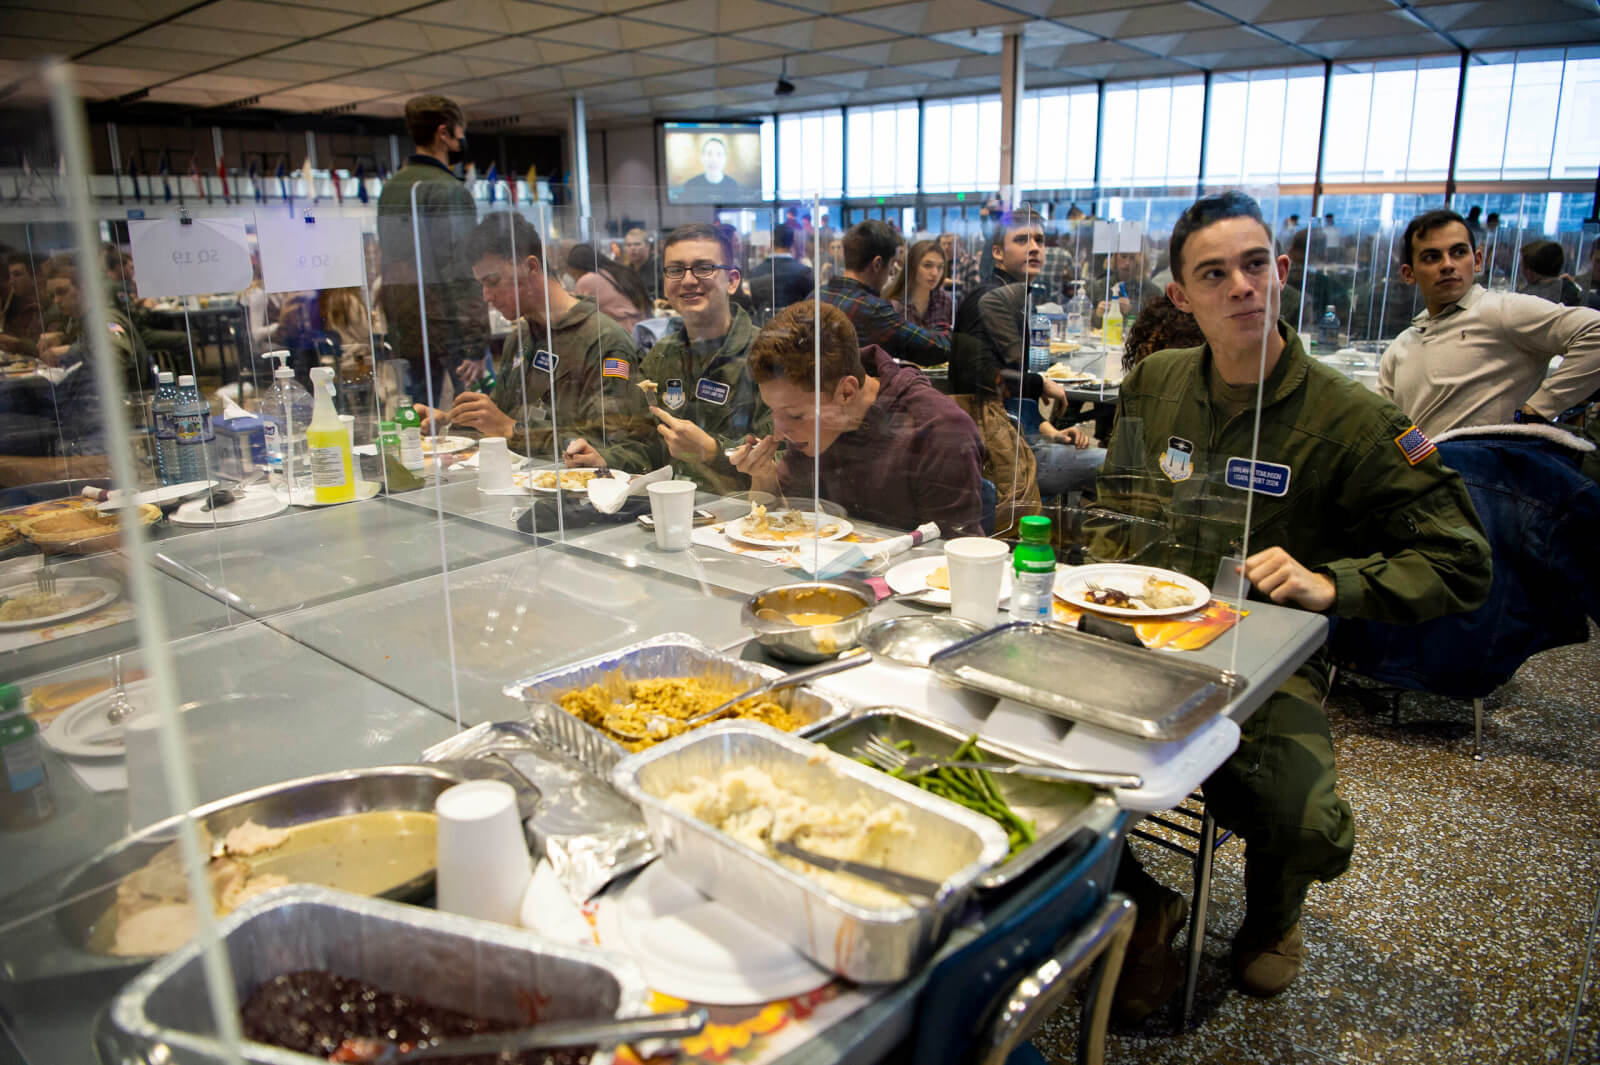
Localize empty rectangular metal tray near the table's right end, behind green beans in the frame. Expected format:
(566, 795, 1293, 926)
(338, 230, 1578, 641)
(928, 622, 1246, 740)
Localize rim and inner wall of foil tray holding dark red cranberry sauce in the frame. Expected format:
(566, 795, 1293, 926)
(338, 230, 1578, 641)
(110, 886, 650, 1065)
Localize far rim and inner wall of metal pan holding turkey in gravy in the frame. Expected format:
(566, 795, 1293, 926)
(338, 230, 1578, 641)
(0, 766, 470, 982)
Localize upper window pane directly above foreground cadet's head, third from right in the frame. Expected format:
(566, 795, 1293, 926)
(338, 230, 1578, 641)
(1205, 67, 1323, 185)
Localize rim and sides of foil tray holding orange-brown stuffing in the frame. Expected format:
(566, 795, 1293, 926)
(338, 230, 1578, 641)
(504, 632, 850, 777)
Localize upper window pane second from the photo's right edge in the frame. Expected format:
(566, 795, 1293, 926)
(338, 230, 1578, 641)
(1322, 56, 1461, 181)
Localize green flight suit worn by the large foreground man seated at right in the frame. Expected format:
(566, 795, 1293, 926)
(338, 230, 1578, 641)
(1091, 323, 1490, 942)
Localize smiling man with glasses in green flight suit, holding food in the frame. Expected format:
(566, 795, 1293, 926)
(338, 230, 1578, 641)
(611, 224, 773, 493)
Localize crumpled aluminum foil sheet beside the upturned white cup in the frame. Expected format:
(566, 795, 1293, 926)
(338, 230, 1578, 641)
(422, 715, 656, 903)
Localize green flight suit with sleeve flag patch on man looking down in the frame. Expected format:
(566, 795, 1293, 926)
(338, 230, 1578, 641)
(490, 299, 656, 473)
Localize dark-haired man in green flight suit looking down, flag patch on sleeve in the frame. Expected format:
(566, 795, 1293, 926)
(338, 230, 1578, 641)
(421, 211, 654, 473)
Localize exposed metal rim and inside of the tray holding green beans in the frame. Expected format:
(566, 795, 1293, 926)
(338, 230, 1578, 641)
(813, 707, 1117, 891)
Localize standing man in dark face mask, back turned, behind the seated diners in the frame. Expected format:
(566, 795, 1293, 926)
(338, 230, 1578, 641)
(378, 96, 490, 405)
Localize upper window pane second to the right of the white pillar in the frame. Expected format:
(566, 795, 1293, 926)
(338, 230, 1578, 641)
(1101, 77, 1205, 187)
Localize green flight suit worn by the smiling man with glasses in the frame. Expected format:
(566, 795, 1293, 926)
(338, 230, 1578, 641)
(638, 307, 773, 494)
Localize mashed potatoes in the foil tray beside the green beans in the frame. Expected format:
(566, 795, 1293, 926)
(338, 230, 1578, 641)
(666, 766, 912, 910)
